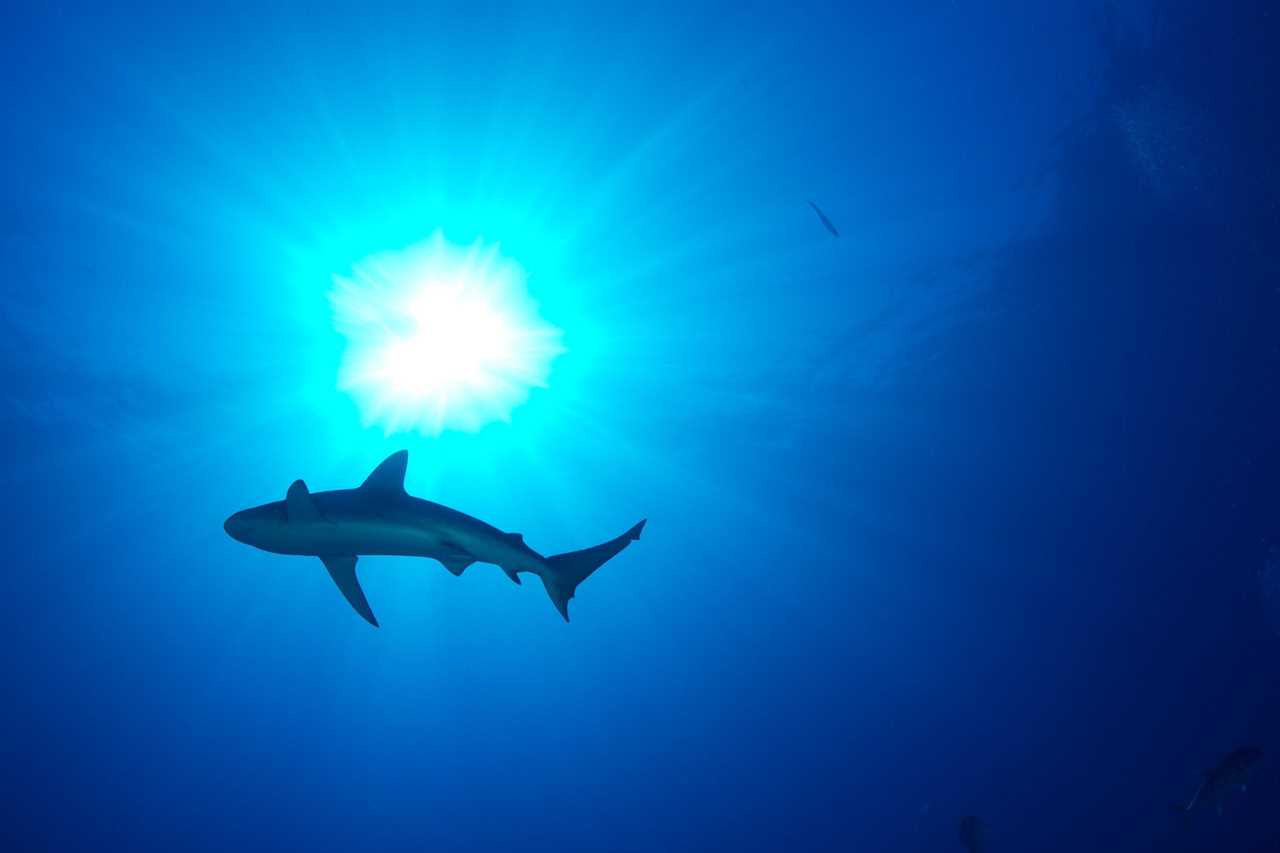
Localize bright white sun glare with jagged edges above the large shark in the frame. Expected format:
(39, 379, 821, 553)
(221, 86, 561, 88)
(329, 232, 564, 434)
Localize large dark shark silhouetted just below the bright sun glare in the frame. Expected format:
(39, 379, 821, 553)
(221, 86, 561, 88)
(223, 450, 645, 628)
